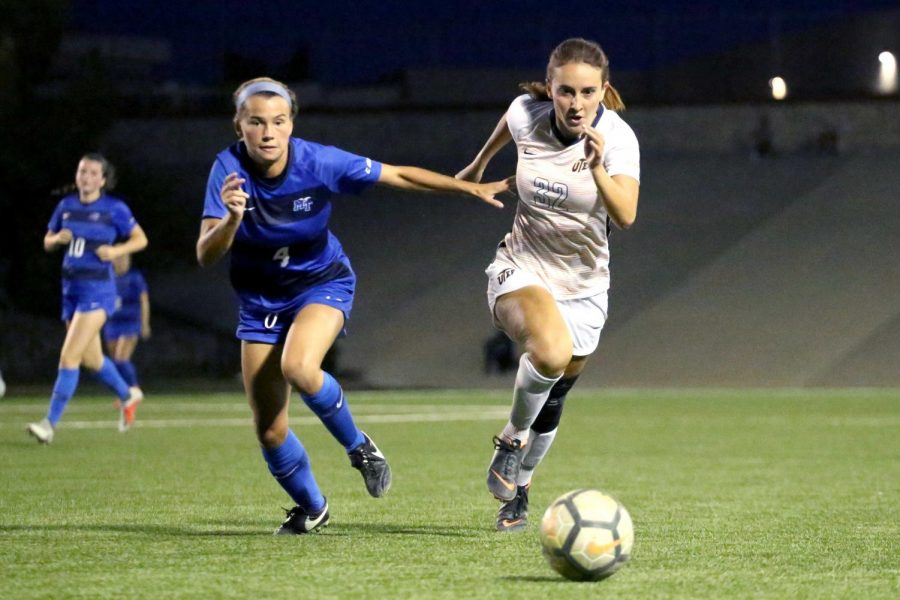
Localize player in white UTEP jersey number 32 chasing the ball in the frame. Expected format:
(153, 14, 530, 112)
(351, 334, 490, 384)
(457, 38, 640, 531)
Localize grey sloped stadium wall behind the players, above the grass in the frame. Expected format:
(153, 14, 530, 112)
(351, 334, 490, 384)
(75, 101, 900, 387)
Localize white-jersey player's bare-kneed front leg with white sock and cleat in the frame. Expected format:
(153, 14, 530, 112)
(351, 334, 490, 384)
(487, 285, 572, 502)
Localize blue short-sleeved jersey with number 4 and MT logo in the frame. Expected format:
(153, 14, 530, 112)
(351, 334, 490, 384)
(203, 138, 381, 311)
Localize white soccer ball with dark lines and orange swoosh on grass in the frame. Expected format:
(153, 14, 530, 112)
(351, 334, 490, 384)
(541, 490, 634, 581)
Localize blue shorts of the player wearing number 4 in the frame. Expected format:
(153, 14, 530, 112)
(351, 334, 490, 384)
(237, 277, 356, 344)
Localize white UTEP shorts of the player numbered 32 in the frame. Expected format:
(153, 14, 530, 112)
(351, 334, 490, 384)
(485, 261, 608, 356)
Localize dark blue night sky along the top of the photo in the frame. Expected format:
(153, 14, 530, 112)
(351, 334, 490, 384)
(70, 0, 900, 84)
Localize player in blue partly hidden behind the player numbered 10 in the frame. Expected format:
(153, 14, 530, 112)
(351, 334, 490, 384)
(103, 254, 150, 429)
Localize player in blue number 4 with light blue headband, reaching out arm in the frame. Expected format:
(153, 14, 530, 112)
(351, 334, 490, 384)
(197, 77, 508, 534)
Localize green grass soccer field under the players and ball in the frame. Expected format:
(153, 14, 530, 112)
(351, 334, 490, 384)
(0, 390, 900, 599)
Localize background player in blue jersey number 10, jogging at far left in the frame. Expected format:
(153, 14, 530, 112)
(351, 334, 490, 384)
(27, 153, 147, 444)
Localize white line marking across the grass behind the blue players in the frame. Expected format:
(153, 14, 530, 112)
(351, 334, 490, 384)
(0, 406, 509, 429)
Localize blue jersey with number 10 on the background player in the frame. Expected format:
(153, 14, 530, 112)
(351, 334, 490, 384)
(47, 194, 137, 297)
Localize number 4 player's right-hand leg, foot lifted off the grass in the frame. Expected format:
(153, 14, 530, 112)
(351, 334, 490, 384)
(281, 304, 391, 498)
